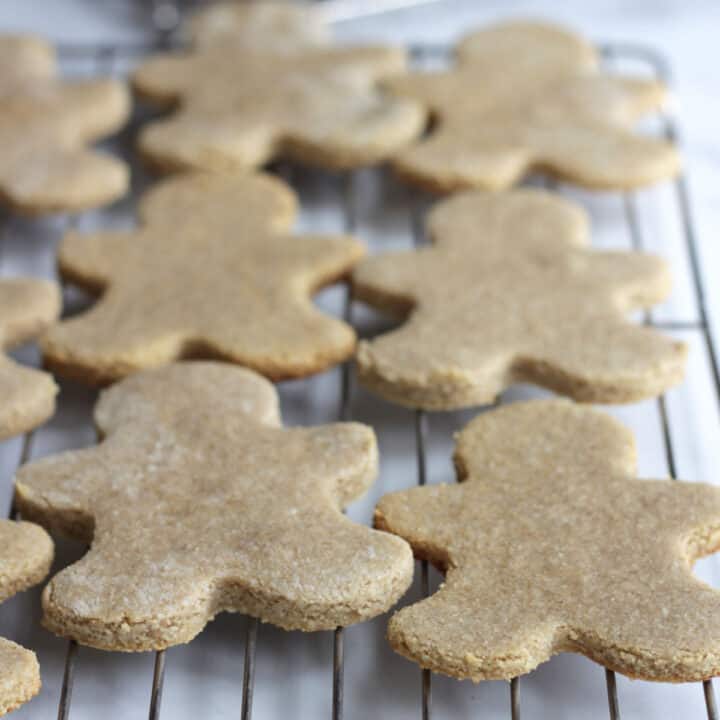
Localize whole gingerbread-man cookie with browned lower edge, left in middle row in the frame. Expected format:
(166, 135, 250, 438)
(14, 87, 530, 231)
(42, 173, 364, 384)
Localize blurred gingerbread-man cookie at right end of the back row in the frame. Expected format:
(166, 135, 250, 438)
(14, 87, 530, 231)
(388, 22, 679, 192)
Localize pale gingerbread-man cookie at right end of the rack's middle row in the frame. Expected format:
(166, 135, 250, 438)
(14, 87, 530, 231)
(353, 189, 686, 410)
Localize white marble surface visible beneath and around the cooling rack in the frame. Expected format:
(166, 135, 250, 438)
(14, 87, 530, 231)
(0, 0, 720, 720)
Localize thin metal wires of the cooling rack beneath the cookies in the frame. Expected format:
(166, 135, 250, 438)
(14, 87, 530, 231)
(0, 22, 720, 720)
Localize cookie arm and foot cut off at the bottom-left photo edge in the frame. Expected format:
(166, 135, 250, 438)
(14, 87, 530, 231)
(0, 520, 53, 715)
